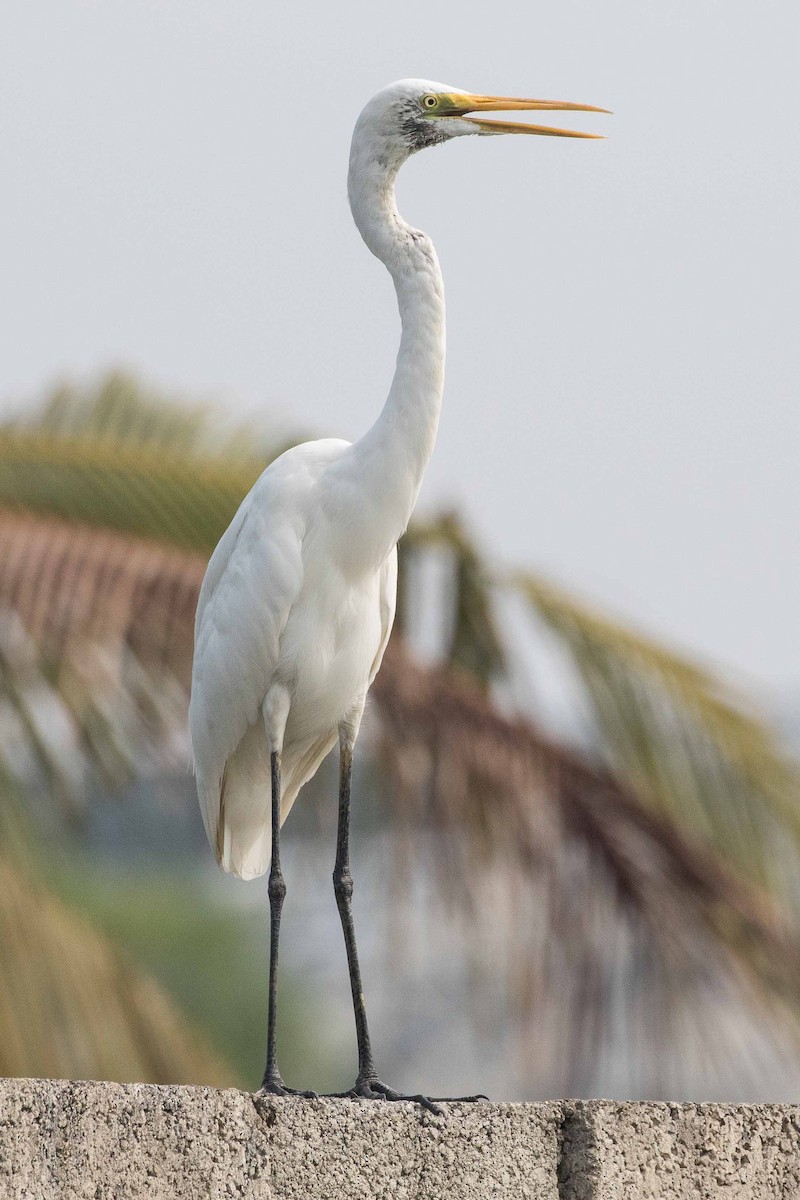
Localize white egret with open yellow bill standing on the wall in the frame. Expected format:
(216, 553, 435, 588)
(190, 79, 606, 1104)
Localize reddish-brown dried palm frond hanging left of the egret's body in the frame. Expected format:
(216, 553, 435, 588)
(0, 510, 205, 817)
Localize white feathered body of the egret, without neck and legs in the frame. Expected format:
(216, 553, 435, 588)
(190, 438, 397, 880)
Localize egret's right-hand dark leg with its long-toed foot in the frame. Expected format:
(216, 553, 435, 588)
(333, 733, 486, 1114)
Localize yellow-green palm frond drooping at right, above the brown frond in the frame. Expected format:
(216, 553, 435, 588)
(512, 574, 800, 887)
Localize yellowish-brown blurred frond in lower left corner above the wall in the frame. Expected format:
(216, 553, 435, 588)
(0, 779, 237, 1087)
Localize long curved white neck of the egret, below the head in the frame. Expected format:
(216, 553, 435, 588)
(335, 143, 445, 562)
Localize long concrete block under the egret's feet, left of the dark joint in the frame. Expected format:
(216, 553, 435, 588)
(0, 1079, 560, 1200)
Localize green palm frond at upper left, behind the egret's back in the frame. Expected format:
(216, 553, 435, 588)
(0, 373, 297, 553)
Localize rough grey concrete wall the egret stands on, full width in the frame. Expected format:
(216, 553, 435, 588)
(0, 1080, 800, 1200)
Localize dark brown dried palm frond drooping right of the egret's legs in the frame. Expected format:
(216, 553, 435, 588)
(373, 643, 800, 1094)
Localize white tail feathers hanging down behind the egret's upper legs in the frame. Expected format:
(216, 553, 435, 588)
(198, 722, 336, 880)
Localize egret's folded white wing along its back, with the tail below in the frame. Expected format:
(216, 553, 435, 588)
(190, 439, 347, 878)
